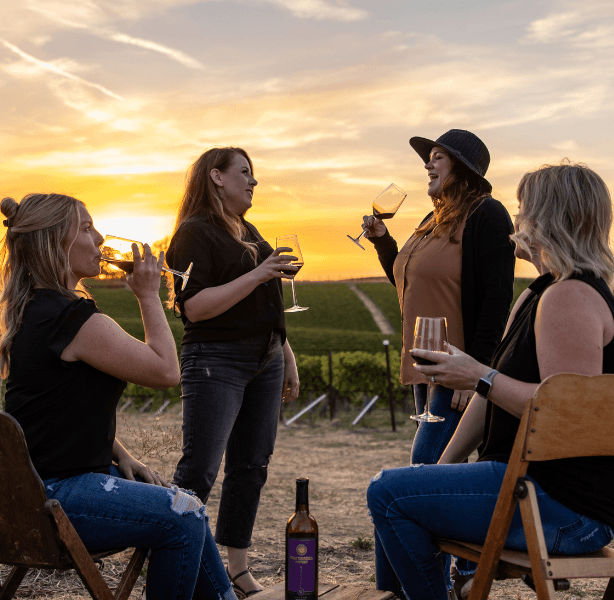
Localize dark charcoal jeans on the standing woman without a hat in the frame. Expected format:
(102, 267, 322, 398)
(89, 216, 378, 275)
(174, 332, 284, 548)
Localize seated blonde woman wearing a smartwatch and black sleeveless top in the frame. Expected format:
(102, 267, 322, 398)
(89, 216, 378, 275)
(368, 164, 614, 600)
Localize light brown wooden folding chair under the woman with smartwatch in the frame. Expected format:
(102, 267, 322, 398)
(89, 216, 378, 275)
(437, 374, 614, 600)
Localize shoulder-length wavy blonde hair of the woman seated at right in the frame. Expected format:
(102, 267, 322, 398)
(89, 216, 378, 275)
(511, 161, 614, 287)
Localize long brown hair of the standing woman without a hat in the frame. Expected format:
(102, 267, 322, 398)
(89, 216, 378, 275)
(173, 146, 258, 262)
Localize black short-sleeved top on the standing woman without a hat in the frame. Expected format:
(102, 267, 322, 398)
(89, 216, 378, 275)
(166, 215, 286, 344)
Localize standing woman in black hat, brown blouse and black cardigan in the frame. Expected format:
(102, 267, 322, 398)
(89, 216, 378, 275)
(363, 129, 514, 593)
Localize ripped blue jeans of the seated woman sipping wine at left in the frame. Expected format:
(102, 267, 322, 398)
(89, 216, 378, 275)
(43, 465, 236, 600)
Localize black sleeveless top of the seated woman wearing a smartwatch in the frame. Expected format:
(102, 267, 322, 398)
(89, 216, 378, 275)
(479, 273, 614, 527)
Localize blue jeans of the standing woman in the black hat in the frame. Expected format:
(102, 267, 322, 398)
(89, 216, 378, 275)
(414, 383, 477, 588)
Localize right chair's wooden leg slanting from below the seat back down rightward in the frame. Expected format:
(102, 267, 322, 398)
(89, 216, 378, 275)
(520, 480, 555, 600)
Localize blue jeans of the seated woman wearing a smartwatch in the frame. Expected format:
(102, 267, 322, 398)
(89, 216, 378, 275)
(367, 462, 614, 600)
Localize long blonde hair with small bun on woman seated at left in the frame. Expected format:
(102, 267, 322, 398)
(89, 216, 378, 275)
(0, 194, 87, 378)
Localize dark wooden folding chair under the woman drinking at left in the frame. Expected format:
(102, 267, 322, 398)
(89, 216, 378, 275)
(0, 411, 148, 600)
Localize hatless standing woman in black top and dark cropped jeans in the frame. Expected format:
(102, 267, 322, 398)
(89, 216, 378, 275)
(167, 148, 299, 595)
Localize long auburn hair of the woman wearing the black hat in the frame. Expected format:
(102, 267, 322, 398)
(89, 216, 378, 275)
(415, 150, 490, 244)
